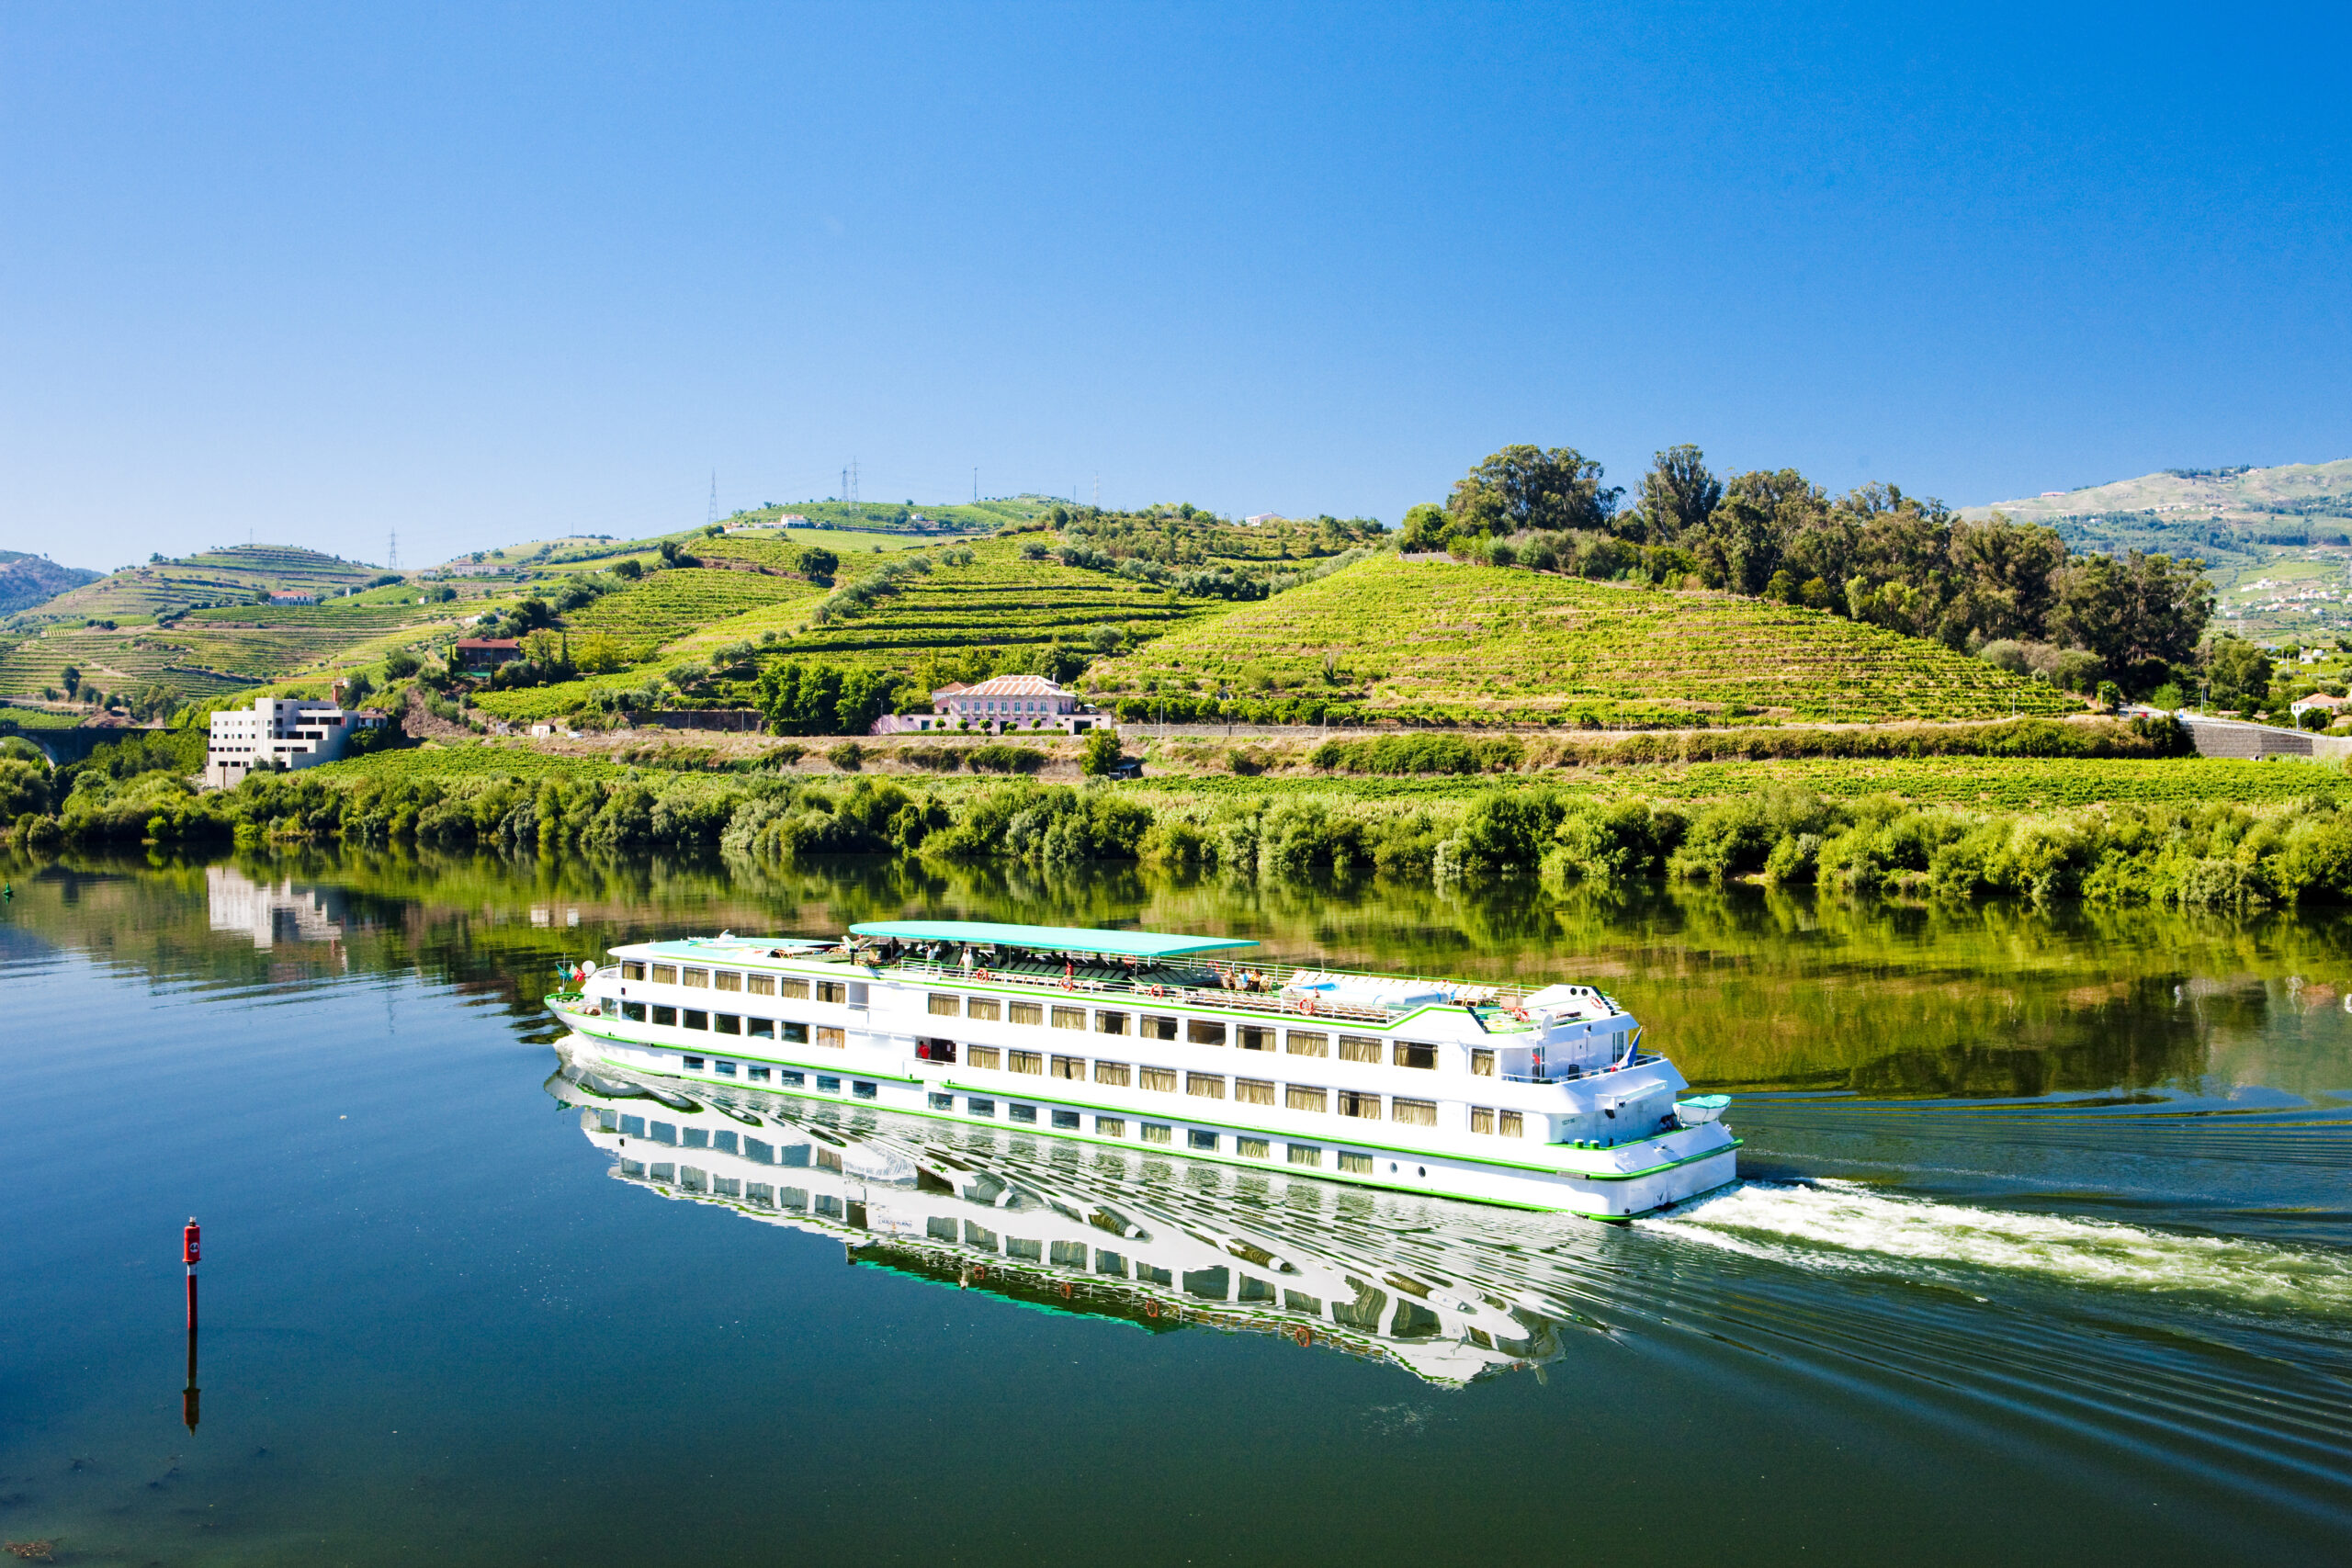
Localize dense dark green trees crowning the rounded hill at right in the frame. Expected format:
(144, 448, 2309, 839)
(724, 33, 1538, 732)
(1404, 434, 2213, 691)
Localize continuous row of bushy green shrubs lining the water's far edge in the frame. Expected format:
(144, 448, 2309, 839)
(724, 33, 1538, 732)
(14, 736, 2352, 909)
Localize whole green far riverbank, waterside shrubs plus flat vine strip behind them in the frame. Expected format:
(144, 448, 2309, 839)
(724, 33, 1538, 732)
(7, 745, 2352, 908)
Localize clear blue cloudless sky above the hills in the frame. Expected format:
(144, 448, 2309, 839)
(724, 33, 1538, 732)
(0, 3, 2352, 567)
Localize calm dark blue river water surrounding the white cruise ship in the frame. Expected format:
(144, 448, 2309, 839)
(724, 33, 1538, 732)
(0, 856, 2352, 1568)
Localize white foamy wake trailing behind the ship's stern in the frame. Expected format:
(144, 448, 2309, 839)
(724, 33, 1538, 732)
(1639, 1180, 2352, 1316)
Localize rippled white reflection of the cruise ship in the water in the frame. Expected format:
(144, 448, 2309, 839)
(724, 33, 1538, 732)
(548, 1055, 1600, 1387)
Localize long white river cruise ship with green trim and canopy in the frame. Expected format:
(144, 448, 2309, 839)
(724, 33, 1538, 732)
(548, 921, 1738, 1220)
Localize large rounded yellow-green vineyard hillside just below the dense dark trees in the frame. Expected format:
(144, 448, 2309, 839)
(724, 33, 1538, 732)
(1093, 555, 2082, 727)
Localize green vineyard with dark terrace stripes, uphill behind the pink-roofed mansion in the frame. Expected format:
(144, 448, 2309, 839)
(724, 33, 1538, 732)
(790, 538, 1230, 670)
